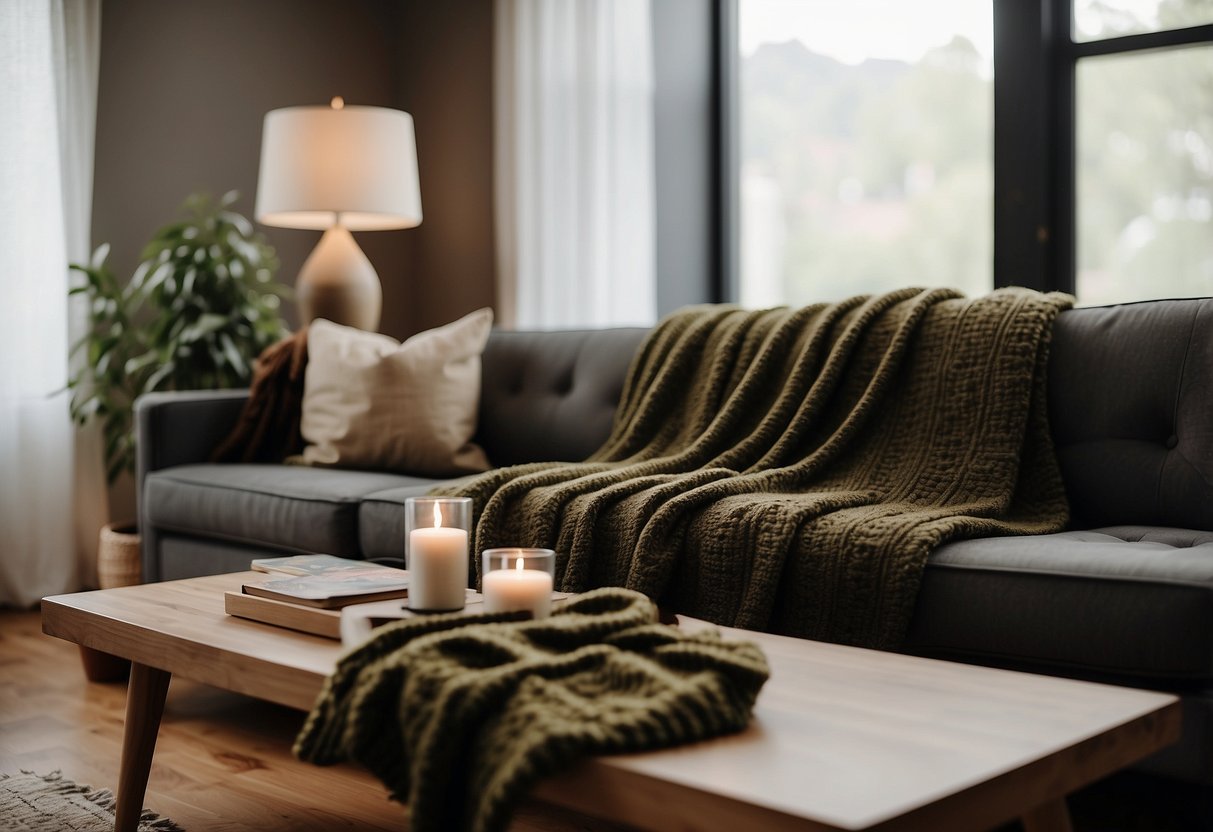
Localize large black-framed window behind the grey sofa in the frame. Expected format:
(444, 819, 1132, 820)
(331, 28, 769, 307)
(721, 0, 1213, 306)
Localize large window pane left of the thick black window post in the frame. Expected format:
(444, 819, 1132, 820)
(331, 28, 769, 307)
(739, 0, 993, 306)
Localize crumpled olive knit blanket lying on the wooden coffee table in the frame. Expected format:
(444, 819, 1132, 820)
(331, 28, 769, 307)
(295, 589, 768, 832)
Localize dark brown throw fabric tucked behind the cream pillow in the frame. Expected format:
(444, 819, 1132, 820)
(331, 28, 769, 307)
(211, 326, 307, 462)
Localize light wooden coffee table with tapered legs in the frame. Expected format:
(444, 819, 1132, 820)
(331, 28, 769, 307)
(42, 572, 1180, 832)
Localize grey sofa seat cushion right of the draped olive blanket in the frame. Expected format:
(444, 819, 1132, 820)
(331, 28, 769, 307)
(905, 526, 1213, 684)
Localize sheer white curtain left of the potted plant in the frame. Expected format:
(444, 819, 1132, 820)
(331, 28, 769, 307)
(0, 0, 103, 613)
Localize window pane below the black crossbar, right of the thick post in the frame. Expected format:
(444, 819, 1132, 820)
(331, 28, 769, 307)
(1077, 47, 1213, 303)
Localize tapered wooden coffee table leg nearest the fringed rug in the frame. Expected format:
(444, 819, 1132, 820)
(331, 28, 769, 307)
(114, 662, 172, 832)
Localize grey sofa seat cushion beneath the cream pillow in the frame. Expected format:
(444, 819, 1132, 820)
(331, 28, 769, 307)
(142, 465, 432, 558)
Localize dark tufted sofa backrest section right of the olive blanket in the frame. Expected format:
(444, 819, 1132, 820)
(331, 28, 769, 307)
(1049, 298, 1213, 530)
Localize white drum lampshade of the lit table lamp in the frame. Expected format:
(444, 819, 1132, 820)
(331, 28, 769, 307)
(255, 107, 421, 232)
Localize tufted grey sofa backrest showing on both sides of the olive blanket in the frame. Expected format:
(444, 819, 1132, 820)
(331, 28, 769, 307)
(477, 298, 1213, 530)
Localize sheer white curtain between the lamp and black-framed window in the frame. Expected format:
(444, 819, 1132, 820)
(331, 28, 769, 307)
(494, 0, 656, 329)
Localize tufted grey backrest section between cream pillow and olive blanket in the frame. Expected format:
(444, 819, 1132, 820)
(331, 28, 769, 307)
(475, 329, 649, 466)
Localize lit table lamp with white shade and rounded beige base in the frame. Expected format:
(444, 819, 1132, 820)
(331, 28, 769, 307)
(255, 97, 421, 331)
